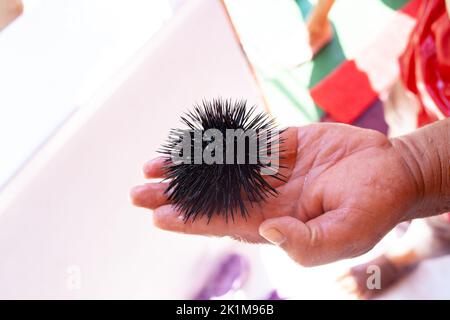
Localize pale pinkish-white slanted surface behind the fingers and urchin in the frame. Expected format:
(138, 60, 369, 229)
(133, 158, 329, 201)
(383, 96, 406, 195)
(0, 0, 265, 299)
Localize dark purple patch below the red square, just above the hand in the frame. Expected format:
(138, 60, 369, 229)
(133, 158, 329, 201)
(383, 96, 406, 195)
(320, 99, 389, 134)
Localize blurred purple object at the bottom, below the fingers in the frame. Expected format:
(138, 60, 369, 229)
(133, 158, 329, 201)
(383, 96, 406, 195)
(194, 253, 249, 300)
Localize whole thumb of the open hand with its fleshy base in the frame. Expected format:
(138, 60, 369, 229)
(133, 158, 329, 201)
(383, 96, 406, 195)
(259, 208, 384, 267)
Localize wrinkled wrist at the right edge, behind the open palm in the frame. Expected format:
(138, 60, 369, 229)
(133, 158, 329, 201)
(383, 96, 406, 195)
(391, 119, 450, 219)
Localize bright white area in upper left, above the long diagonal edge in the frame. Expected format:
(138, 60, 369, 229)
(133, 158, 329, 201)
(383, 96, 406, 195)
(0, 0, 171, 188)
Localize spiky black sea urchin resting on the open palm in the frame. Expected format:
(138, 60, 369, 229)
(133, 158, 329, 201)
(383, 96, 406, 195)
(159, 99, 284, 221)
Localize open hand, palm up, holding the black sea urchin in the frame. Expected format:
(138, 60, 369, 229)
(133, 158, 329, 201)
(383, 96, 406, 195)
(131, 121, 450, 266)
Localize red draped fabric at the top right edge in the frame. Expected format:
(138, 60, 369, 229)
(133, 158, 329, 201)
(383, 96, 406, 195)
(400, 0, 450, 125)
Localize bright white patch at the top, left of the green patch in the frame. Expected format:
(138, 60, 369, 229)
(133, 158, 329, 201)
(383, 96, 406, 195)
(225, 0, 312, 76)
